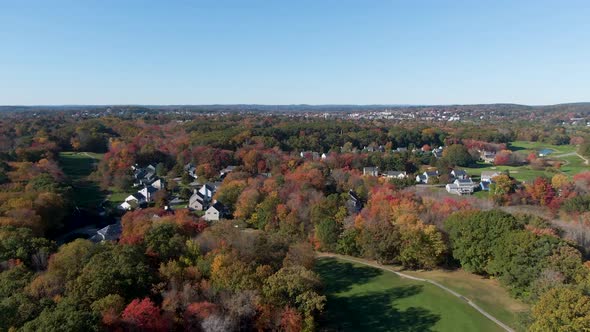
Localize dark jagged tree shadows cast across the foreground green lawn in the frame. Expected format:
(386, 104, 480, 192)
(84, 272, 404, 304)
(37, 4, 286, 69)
(316, 259, 440, 332)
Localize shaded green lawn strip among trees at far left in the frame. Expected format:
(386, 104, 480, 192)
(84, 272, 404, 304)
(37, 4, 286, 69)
(59, 152, 104, 208)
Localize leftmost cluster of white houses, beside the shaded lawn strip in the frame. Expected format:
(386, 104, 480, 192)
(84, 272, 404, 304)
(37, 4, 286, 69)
(119, 165, 165, 211)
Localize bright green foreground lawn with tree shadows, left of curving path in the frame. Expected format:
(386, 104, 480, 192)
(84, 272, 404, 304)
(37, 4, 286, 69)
(315, 258, 502, 332)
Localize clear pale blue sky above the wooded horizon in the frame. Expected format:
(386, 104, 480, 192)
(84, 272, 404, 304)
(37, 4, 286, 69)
(0, 0, 590, 105)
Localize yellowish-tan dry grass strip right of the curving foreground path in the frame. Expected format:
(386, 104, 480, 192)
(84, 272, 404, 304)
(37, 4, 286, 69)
(403, 270, 530, 331)
